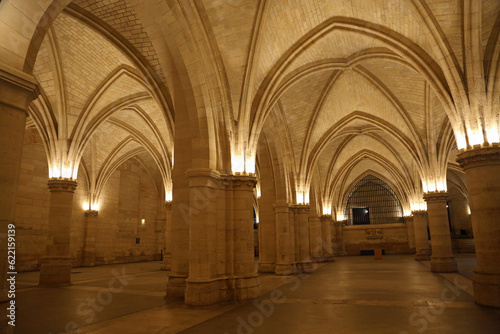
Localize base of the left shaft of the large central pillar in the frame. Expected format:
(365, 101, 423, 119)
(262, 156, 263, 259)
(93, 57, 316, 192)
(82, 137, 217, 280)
(184, 278, 228, 306)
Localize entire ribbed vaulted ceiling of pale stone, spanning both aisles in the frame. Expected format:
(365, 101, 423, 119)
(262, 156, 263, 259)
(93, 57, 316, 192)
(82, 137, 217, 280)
(23, 0, 500, 211)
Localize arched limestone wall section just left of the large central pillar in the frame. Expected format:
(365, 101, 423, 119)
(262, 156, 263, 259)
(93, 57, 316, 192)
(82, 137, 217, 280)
(92, 159, 163, 264)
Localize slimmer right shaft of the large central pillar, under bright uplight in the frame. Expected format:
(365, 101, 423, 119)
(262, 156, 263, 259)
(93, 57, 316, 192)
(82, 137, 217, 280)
(231, 175, 260, 300)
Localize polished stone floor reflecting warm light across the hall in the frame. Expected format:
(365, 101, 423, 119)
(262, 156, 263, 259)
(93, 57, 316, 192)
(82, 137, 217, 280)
(15, 254, 500, 334)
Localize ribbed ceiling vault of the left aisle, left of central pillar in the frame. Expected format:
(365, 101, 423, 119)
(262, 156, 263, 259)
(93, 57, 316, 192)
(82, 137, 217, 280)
(32, 7, 173, 196)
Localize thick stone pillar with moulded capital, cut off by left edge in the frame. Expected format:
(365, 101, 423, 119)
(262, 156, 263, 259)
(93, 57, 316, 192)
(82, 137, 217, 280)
(0, 68, 38, 333)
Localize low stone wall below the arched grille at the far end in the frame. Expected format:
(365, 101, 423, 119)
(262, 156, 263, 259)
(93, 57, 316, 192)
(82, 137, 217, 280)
(344, 223, 411, 255)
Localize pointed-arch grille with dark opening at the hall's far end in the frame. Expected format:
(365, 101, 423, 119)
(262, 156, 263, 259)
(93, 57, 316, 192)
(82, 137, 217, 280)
(344, 175, 404, 225)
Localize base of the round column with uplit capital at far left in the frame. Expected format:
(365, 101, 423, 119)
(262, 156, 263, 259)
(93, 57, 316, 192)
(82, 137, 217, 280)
(39, 257, 71, 287)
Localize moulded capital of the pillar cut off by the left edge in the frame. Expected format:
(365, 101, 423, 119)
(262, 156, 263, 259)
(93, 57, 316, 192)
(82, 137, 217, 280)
(0, 65, 40, 115)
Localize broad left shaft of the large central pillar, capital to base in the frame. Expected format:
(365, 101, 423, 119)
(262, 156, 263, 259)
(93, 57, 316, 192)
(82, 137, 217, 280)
(184, 169, 223, 306)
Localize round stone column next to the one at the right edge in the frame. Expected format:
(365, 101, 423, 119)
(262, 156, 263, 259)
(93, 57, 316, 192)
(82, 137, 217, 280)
(424, 192, 458, 273)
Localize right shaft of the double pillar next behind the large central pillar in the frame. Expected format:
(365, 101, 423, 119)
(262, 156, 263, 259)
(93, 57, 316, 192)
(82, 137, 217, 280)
(292, 204, 313, 273)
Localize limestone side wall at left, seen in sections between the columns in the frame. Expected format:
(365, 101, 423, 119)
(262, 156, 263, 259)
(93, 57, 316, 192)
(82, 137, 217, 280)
(15, 129, 165, 272)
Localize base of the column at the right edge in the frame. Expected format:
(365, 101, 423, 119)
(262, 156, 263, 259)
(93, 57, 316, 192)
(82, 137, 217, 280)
(472, 271, 500, 308)
